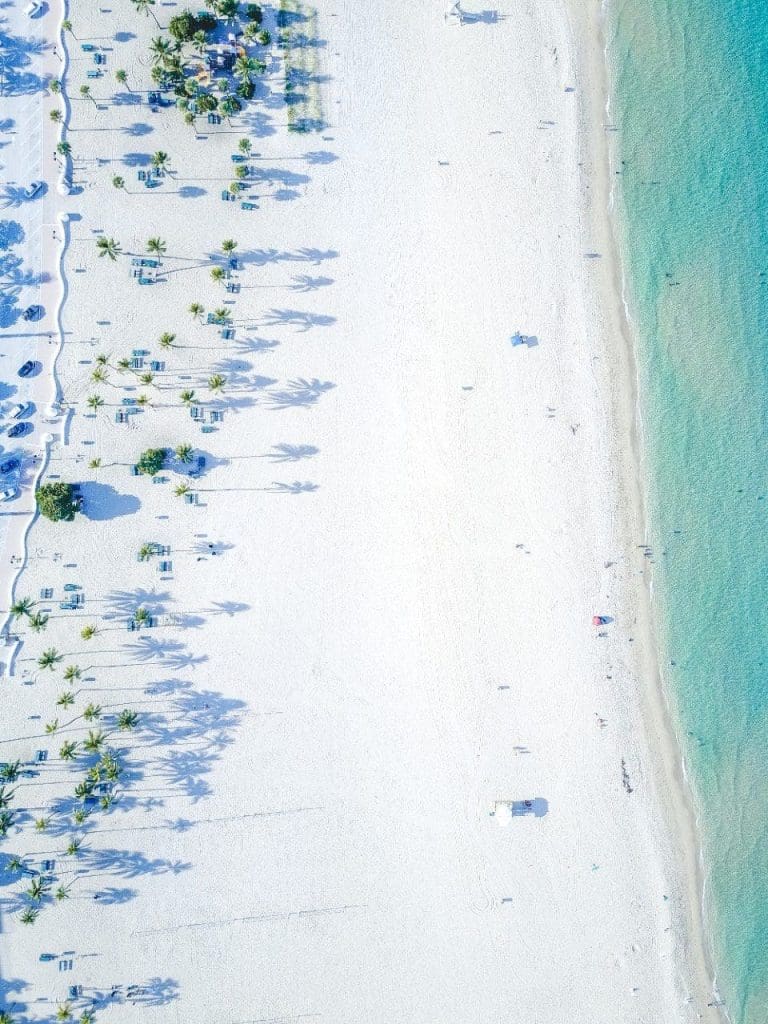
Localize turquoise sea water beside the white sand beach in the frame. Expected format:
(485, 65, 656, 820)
(608, 0, 768, 1024)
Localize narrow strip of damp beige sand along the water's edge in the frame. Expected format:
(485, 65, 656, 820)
(565, 0, 730, 1022)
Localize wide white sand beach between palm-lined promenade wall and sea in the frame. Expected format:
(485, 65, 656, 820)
(0, 0, 716, 1024)
